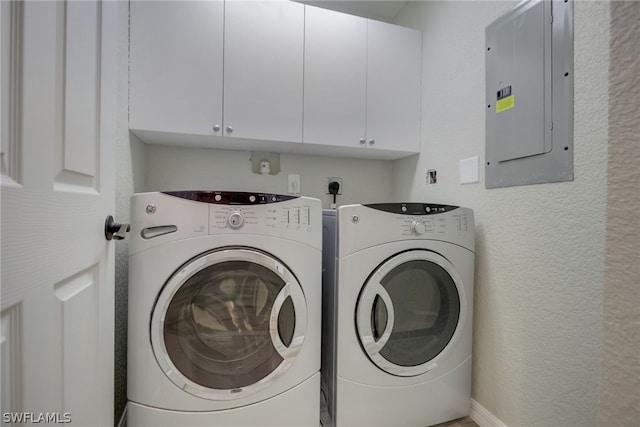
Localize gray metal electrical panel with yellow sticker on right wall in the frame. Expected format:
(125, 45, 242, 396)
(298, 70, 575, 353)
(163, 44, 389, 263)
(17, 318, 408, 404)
(485, 0, 573, 188)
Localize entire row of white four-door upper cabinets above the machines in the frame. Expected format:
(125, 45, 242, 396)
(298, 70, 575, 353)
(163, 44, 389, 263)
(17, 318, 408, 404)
(129, 0, 422, 159)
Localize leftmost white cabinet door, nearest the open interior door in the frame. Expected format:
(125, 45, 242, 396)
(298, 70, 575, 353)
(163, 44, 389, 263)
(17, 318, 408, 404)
(129, 0, 224, 135)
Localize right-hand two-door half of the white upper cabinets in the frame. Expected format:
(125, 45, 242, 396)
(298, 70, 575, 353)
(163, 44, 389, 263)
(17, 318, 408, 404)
(303, 6, 422, 157)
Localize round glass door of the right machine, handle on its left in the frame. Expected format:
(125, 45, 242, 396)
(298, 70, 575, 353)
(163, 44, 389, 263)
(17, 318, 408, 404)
(356, 250, 466, 377)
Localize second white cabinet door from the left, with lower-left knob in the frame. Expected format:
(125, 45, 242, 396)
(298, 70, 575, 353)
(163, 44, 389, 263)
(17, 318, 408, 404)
(224, 1, 304, 142)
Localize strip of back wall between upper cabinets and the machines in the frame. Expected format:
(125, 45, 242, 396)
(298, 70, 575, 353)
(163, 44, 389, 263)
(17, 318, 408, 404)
(144, 144, 393, 208)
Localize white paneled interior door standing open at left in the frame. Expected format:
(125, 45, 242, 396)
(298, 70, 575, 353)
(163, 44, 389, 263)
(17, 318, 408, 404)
(0, 1, 122, 426)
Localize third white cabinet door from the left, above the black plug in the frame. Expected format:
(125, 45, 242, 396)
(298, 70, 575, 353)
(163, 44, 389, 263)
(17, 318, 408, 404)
(303, 6, 367, 147)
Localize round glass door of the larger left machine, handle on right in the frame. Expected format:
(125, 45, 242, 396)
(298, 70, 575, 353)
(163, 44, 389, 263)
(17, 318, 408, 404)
(151, 248, 307, 400)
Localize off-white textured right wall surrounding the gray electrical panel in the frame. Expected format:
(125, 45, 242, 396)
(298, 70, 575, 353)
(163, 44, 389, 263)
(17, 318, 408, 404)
(394, 1, 609, 427)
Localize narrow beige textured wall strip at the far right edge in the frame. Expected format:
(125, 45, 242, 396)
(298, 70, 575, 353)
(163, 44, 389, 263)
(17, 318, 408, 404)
(600, 2, 640, 427)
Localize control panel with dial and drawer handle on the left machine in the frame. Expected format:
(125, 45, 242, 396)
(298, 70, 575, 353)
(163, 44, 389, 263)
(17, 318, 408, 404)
(129, 191, 322, 254)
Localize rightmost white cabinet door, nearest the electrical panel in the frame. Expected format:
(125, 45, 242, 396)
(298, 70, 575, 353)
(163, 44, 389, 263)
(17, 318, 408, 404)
(367, 20, 422, 152)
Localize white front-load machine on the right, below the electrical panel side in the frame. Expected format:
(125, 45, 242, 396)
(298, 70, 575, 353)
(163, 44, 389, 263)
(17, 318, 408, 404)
(322, 203, 474, 427)
